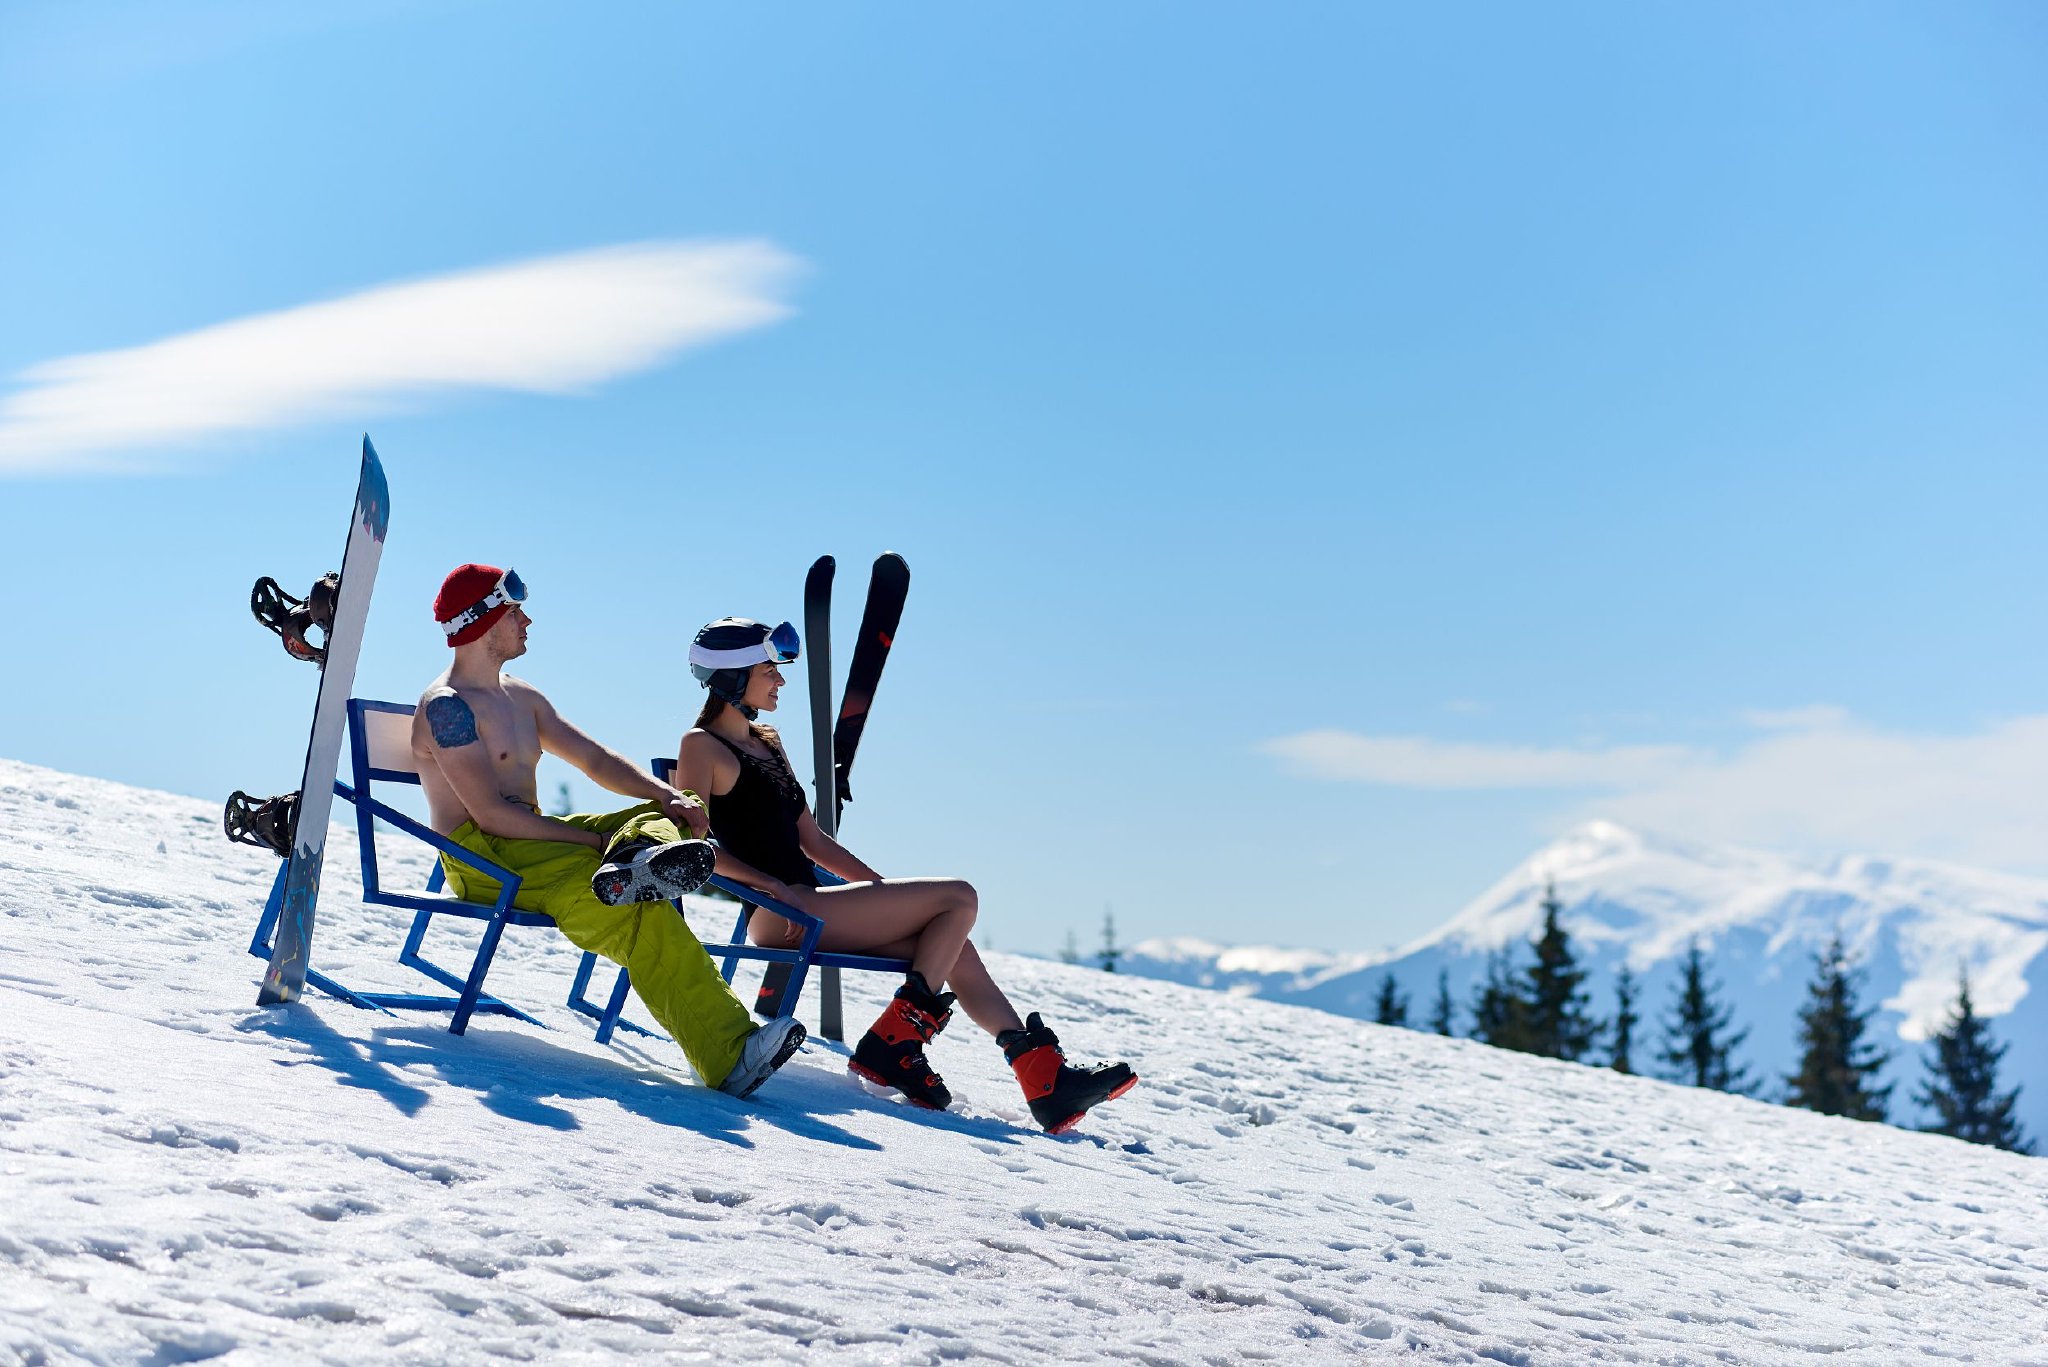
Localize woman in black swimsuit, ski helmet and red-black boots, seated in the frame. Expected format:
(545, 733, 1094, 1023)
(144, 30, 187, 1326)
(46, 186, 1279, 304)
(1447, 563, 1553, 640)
(674, 617, 1137, 1133)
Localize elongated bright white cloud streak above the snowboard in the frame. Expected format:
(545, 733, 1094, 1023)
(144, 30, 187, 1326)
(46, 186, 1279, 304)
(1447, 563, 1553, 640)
(0, 242, 799, 475)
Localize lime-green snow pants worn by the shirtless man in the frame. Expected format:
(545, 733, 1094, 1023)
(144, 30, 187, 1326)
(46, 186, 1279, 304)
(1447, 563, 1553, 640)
(440, 801, 754, 1086)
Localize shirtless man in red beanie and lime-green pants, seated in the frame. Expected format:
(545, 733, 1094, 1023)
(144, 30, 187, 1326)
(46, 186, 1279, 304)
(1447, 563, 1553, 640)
(412, 566, 803, 1096)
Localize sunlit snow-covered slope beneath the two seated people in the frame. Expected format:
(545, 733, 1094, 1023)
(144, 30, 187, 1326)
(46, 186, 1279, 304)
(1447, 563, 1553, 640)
(0, 762, 2048, 1365)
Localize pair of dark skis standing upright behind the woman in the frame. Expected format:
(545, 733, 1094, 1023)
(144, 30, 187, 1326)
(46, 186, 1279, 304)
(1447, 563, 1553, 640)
(754, 551, 909, 1041)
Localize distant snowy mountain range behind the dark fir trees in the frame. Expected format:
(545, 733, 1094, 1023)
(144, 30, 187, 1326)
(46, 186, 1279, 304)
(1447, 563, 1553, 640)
(1118, 822, 2048, 1148)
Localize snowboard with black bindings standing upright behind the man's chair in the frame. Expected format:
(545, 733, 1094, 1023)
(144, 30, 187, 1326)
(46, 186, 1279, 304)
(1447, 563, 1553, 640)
(225, 437, 391, 1006)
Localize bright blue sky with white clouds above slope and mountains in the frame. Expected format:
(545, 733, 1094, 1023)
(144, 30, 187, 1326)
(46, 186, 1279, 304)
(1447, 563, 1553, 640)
(0, 4, 2048, 951)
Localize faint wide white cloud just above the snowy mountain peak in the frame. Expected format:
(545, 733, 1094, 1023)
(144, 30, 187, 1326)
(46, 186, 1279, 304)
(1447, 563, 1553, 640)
(1264, 707, 2048, 871)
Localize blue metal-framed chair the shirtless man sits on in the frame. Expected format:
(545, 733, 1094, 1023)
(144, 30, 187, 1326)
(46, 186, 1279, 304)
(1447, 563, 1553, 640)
(250, 697, 653, 1041)
